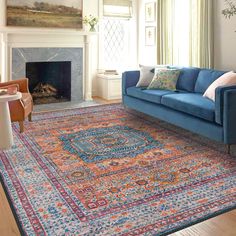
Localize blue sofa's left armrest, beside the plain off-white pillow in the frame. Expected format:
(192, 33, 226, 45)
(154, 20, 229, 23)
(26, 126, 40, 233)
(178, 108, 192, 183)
(122, 70, 140, 95)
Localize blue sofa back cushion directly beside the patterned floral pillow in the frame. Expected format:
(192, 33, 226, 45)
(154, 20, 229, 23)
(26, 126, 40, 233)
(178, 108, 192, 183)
(176, 67, 200, 92)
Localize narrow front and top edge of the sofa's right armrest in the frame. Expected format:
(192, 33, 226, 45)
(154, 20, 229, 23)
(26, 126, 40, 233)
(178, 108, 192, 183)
(215, 86, 236, 125)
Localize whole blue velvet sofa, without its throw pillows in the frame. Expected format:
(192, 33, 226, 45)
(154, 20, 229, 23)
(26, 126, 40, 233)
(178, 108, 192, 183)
(122, 68, 236, 152)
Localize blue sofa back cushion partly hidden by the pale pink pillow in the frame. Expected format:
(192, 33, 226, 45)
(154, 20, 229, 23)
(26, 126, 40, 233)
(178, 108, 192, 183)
(194, 69, 225, 94)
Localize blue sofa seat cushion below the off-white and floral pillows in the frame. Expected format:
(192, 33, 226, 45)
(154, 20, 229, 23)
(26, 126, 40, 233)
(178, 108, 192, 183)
(127, 87, 174, 104)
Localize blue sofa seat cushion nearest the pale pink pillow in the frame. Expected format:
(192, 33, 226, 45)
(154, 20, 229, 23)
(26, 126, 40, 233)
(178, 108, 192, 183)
(161, 93, 215, 122)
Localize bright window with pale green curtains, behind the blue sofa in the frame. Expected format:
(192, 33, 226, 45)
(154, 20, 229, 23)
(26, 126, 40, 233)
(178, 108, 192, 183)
(157, 0, 213, 68)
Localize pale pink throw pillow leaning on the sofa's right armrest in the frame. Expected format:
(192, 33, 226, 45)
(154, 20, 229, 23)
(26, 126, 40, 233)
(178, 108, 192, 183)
(203, 71, 236, 101)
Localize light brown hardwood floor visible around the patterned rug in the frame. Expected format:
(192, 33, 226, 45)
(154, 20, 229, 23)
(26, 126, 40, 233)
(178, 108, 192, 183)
(0, 98, 236, 236)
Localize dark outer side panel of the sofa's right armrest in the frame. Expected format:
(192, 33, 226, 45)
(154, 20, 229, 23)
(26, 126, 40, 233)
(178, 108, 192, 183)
(223, 88, 236, 144)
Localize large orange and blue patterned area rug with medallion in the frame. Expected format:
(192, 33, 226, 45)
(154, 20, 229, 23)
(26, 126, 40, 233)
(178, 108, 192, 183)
(0, 104, 236, 236)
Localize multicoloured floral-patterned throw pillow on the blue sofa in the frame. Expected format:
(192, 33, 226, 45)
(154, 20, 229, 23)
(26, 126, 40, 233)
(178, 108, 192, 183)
(147, 69, 180, 90)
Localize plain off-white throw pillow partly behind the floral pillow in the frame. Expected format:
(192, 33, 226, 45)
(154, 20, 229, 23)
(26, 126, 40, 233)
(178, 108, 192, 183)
(136, 65, 166, 87)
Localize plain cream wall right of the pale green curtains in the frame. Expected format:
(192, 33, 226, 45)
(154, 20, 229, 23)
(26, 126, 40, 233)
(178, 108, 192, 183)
(214, 0, 236, 70)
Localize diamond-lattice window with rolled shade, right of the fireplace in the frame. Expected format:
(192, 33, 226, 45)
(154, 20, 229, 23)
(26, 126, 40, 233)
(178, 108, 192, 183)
(99, 0, 132, 71)
